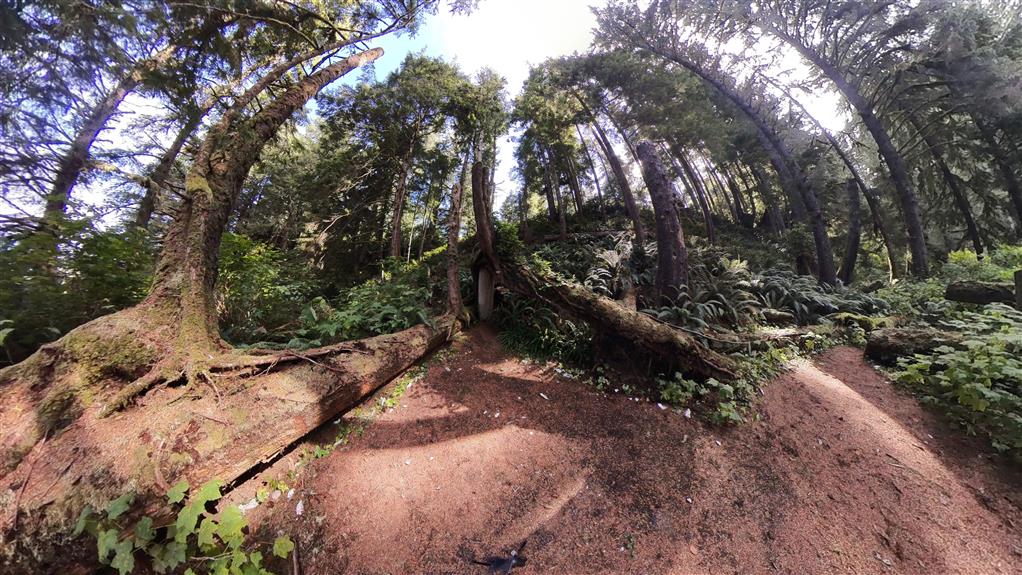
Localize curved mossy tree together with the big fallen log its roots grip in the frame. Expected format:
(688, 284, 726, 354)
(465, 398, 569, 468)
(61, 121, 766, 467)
(0, 49, 404, 567)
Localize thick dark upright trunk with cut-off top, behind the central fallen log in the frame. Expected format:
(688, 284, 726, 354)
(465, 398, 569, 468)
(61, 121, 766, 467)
(636, 140, 689, 303)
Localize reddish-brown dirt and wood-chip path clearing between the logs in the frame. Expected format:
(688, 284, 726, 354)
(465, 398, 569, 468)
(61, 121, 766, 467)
(241, 326, 1022, 575)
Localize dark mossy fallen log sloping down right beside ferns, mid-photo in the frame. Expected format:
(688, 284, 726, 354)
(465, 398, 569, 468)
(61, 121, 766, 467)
(501, 260, 736, 381)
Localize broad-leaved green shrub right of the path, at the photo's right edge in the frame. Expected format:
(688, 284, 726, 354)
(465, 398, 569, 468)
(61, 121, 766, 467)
(895, 303, 1022, 454)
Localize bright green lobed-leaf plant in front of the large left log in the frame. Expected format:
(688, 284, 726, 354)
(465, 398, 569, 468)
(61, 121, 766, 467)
(73, 480, 294, 575)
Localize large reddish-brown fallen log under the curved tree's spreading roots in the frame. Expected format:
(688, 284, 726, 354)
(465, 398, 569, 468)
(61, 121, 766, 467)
(0, 316, 458, 573)
